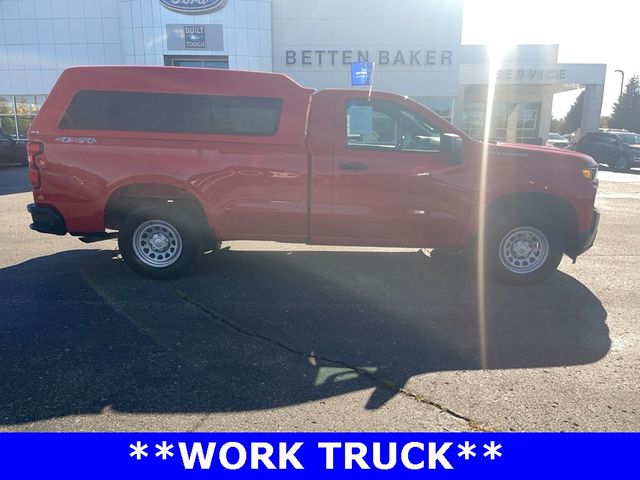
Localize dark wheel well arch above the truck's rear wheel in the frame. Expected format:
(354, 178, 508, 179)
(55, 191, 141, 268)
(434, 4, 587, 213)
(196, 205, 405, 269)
(104, 183, 213, 238)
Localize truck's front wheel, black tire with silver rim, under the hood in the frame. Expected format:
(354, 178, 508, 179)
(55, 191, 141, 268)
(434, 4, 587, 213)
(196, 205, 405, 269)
(485, 213, 564, 285)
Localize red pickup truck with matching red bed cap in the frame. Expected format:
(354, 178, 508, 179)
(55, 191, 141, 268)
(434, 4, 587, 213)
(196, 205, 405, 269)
(28, 66, 599, 284)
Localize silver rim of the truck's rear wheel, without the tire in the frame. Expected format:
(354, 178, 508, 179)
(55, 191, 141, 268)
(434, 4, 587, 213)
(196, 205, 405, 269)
(133, 220, 182, 268)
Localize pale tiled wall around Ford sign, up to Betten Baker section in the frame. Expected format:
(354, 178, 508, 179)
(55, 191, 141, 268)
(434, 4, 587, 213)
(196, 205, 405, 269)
(0, 0, 272, 95)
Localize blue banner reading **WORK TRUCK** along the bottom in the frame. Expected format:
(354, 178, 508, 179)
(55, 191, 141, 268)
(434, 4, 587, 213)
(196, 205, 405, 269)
(0, 433, 640, 480)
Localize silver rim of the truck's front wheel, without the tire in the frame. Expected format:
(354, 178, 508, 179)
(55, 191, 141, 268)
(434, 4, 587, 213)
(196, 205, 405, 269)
(500, 227, 549, 274)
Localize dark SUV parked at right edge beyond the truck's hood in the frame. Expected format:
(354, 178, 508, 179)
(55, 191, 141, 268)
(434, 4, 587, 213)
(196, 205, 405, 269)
(575, 130, 640, 171)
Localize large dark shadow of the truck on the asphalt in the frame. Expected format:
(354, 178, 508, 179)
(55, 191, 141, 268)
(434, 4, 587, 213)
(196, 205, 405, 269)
(0, 250, 610, 425)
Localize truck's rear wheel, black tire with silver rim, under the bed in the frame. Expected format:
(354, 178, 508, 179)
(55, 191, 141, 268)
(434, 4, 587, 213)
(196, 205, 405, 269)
(118, 206, 202, 280)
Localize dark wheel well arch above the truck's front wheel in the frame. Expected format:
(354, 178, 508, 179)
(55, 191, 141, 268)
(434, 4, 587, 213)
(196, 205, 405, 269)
(487, 193, 578, 252)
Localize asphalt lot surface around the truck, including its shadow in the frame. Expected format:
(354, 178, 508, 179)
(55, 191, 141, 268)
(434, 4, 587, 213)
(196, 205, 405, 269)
(0, 167, 640, 431)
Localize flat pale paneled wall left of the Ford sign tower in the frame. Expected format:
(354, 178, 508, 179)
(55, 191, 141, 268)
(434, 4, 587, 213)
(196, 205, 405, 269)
(0, 0, 123, 95)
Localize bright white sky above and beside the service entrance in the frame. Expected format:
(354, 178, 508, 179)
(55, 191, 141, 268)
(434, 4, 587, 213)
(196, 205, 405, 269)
(462, 0, 640, 118)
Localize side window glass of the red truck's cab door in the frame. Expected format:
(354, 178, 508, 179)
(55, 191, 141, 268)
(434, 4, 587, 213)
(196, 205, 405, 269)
(345, 99, 442, 152)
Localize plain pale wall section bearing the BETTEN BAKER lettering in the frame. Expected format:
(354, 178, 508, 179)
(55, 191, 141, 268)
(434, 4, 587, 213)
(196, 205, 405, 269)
(272, 0, 463, 97)
